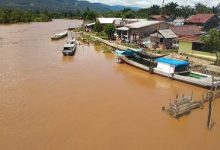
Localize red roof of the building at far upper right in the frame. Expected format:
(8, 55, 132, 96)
(185, 14, 215, 23)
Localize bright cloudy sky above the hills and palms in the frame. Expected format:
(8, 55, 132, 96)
(88, 0, 220, 8)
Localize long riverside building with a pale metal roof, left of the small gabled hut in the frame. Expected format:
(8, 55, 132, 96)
(116, 21, 172, 42)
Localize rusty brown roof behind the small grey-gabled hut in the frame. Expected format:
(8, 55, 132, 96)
(171, 25, 201, 37)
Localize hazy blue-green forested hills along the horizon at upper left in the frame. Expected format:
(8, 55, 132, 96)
(0, 0, 141, 12)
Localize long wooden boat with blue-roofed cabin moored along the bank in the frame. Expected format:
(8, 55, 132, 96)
(115, 50, 220, 88)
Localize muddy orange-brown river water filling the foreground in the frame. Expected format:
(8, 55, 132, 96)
(0, 20, 220, 150)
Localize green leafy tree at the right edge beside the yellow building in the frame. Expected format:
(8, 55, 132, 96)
(202, 29, 220, 65)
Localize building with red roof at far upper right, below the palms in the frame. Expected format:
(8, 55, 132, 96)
(184, 14, 220, 31)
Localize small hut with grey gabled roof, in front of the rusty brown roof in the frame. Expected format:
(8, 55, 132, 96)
(150, 29, 178, 49)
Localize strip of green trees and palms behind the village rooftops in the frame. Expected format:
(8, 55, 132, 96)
(100, 2, 220, 19)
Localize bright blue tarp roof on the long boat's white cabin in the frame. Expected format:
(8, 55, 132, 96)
(156, 57, 189, 67)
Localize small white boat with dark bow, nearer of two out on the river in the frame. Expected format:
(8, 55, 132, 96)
(62, 39, 76, 56)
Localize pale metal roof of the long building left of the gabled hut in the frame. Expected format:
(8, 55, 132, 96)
(125, 21, 163, 29)
